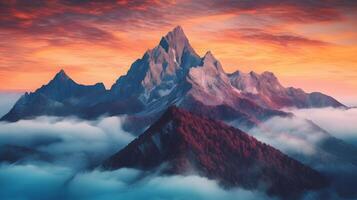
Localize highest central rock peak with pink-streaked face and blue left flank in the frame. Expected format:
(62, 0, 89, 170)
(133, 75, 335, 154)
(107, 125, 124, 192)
(111, 26, 201, 103)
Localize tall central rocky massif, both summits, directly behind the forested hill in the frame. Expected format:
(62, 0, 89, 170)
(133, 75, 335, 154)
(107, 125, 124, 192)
(107, 26, 286, 130)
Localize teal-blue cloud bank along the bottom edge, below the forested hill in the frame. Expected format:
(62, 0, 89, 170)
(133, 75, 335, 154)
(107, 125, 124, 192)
(0, 164, 270, 200)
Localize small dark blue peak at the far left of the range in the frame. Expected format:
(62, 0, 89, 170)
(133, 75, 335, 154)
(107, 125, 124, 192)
(1, 70, 106, 121)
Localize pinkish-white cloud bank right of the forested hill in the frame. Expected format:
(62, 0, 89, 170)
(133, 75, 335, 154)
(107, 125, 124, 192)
(241, 108, 357, 155)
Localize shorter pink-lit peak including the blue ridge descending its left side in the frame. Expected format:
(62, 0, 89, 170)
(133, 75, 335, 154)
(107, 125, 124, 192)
(132, 48, 287, 130)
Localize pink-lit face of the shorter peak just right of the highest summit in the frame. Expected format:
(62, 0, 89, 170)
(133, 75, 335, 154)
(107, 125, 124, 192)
(176, 52, 286, 123)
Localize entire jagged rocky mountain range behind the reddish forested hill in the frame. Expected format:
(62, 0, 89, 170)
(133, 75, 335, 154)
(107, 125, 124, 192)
(1, 26, 345, 122)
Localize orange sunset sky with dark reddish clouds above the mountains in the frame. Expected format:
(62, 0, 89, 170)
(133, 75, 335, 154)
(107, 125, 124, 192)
(0, 0, 357, 104)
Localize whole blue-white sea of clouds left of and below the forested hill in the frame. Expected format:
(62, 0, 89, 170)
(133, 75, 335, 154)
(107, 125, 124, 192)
(0, 116, 269, 200)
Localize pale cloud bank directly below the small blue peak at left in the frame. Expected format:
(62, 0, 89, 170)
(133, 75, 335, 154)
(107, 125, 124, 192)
(0, 117, 134, 168)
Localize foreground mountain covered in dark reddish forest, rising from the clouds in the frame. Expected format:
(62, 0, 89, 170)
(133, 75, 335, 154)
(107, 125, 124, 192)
(102, 107, 327, 198)
